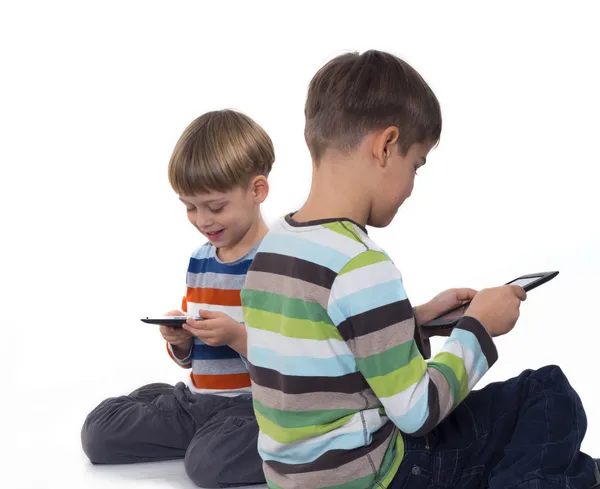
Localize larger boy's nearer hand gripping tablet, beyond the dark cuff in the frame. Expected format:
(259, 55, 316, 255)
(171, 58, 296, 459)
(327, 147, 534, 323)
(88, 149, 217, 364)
(465, 285, 527, 337)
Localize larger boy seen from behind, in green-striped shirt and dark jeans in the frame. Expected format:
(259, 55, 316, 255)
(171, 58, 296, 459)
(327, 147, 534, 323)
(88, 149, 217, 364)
(242, 51, 595, 489)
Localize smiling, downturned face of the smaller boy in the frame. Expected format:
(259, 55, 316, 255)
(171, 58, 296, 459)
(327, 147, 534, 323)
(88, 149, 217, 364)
(179, 177, 268, 249)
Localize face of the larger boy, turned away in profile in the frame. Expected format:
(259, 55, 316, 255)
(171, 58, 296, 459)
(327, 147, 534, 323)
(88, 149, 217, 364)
(367, 138, 433, 227)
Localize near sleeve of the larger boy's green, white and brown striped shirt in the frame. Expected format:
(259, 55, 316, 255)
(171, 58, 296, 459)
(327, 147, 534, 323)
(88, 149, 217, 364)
(328, 250, 497, 436)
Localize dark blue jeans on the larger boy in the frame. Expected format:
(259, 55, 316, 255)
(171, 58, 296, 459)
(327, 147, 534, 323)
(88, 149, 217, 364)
(390, 366, 594, 489)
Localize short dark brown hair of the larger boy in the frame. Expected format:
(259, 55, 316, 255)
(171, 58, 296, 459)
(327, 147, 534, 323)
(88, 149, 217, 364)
(304, 50, 442, 163)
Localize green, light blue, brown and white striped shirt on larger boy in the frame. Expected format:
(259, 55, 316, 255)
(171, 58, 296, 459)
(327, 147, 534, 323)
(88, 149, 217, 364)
(242, 216, 497, 489)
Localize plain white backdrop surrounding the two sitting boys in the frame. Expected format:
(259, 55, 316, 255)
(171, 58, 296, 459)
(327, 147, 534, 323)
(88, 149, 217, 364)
(0, 0, 600, 489)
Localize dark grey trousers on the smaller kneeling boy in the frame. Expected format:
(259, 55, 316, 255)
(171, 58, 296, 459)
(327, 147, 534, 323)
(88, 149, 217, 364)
(81, 382, 265, 488)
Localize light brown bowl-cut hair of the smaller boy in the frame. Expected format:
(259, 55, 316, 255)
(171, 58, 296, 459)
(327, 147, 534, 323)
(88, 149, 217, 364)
(169, 110, 275, 195)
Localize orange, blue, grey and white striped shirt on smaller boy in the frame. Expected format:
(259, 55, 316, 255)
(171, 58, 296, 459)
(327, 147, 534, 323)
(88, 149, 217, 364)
(167, 243, 256, 396)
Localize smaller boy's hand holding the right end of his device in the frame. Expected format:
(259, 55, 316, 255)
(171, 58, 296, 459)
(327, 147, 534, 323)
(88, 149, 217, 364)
(183, 311, 246, 356)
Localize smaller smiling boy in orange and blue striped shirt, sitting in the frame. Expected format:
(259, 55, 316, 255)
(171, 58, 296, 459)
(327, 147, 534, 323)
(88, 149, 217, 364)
(81, 110, 275, 488)
